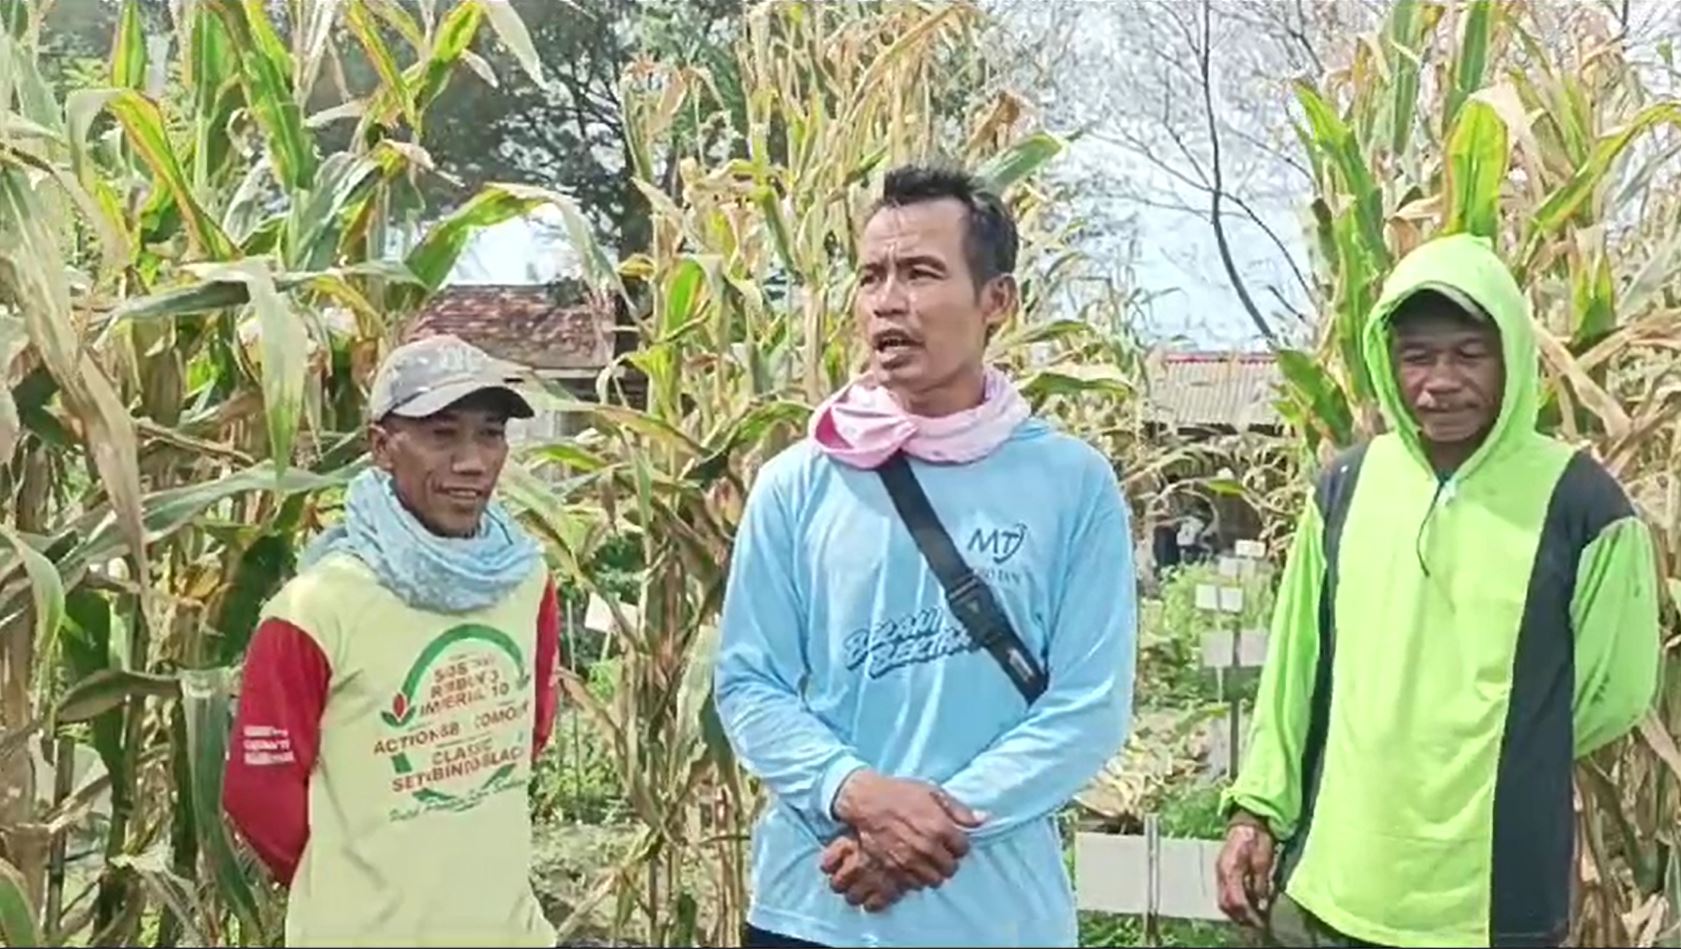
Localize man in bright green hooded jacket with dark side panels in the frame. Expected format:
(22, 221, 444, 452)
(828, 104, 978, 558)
(1219, 235, 1659, 946)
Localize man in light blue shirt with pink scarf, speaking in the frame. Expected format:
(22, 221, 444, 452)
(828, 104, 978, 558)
(716, 166, 1136, 946)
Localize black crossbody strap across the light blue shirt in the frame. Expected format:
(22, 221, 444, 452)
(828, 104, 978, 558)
(876, 454, 1049, 705)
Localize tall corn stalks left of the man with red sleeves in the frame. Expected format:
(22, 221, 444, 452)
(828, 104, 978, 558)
(0, 0, 577, 946)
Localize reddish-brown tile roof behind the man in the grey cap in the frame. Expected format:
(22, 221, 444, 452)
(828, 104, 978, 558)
(403, 282, 615, 371)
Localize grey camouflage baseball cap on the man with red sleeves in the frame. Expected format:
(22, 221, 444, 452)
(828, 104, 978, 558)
(368, 334, 536, 422)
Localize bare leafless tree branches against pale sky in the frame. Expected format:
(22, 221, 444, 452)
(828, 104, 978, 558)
(1000, 0, 1382, 344)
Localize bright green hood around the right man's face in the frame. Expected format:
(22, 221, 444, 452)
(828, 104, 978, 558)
(1362, 233, 1540, 482)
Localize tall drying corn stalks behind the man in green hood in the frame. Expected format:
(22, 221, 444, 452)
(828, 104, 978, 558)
(1281, 0, 1681, 946)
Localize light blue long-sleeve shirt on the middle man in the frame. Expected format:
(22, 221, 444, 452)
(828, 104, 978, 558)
(714, 420, 1136, 946)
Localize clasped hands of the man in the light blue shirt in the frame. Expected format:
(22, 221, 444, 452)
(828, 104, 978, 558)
(820, 769, 985, 912)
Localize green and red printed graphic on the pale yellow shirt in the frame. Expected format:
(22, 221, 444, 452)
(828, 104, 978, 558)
(373, 625, 531, 820)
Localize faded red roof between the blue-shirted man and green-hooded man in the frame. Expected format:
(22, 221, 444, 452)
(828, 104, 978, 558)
(1145, 353, 1283, 430)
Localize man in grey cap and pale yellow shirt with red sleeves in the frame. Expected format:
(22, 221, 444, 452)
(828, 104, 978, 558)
(224, 336, 560, 946)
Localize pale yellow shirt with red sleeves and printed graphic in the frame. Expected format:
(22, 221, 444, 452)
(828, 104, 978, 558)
(224, 554, 558, 946)
